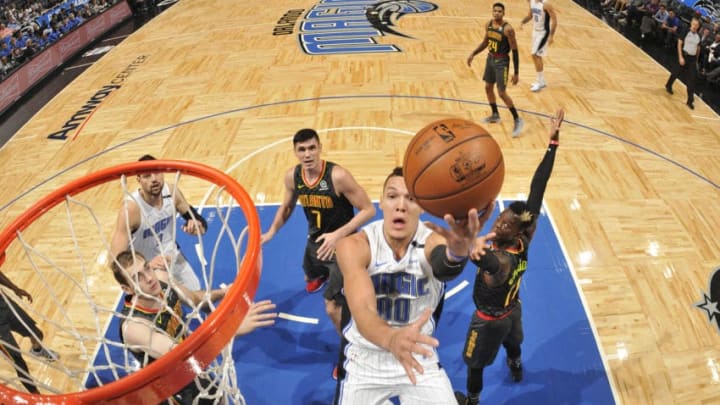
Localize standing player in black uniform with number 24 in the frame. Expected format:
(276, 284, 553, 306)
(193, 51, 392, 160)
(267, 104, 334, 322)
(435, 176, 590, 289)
(467, 3, 525, 138)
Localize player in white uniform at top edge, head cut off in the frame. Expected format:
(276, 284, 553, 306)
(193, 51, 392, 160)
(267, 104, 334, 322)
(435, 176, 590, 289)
(520, 0, 557, 92)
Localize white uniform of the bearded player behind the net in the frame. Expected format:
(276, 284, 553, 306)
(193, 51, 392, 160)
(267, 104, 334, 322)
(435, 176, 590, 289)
(130, 183, 200, 291)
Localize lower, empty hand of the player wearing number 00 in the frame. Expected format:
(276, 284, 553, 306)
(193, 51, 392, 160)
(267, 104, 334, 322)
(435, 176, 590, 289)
(387, 308, 440, 385)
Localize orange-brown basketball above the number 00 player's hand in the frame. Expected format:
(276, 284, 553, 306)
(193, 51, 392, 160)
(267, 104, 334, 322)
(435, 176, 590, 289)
(403, 118, 505, 219)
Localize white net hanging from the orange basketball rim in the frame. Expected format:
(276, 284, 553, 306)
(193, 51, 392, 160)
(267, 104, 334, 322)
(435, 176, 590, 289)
(0, 161, 259, 404)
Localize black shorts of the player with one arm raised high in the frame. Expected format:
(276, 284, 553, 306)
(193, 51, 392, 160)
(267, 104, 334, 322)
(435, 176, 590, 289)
(463, 303, 523, 368)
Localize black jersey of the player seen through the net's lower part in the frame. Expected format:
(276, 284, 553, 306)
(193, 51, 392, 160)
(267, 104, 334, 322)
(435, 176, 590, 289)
(120, 281, 185, 366)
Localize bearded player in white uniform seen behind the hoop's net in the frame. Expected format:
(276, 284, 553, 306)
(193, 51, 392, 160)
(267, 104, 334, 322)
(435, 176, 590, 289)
(110, 155, 207, 291)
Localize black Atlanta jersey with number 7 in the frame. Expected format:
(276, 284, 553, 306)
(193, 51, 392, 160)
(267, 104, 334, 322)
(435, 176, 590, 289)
(293, 161, 355, 241)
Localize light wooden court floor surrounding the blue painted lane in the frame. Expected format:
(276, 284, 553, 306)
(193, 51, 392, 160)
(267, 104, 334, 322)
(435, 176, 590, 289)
(0, 0, 720, 404)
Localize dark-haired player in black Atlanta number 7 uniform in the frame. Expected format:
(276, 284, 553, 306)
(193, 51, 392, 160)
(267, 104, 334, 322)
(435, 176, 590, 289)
(261, 129, 375, 378)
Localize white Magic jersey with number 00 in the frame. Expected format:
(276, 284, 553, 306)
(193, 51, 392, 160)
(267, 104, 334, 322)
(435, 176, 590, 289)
(345, 220, 445, 350)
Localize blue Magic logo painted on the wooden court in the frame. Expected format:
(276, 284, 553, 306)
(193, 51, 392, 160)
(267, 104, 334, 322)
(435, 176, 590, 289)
(273, 0, 438, 55)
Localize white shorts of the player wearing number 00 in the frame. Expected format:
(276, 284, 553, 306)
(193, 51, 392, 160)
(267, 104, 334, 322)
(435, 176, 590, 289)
(337, 346, 457, 405)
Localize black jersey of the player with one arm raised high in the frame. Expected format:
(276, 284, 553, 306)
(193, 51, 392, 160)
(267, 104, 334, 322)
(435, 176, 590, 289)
(473, 237, 528, 316)
